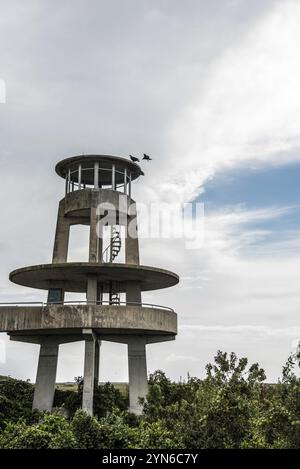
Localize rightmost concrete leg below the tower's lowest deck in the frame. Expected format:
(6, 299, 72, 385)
(128, 337, 148, 415)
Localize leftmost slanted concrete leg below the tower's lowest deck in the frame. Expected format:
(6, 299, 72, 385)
(32, 338, 59, 412)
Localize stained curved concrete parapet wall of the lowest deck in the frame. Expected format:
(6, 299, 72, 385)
(0, 304, 177, 335)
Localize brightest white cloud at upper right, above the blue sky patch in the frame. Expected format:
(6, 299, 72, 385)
(138, 0, 300, 205)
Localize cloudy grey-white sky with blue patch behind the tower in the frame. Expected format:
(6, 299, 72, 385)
(0, 0, 300, 381)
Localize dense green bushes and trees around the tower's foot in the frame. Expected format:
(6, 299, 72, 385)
(0, 352, 300, 449)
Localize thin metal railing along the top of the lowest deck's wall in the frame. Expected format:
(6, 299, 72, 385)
(0, 300, 174, 312)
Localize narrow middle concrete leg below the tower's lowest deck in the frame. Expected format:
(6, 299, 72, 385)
(82, 329, 96, 415)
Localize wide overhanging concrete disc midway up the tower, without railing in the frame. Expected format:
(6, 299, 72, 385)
(9, 262, 179, 293)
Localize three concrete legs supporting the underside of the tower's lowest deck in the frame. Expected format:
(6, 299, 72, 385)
(10, 329, 175, 415)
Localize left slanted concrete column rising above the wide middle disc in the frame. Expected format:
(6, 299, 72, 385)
(52, 200, 70, 264)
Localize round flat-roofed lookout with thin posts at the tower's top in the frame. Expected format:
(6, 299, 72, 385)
(55, 155, 143, 195)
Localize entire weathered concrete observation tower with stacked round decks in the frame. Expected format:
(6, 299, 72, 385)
(0, 155, 179, 415)
